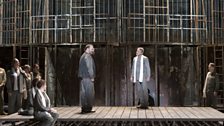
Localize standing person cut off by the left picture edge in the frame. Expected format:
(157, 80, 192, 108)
(0, 62, 6, 115)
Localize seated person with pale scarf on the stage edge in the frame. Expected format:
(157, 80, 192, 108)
(34, 80, 59, 126)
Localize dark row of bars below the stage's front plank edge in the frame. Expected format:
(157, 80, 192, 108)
(8, 120, 222, 126)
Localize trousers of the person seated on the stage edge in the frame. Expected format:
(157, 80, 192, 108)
(34, 111, 59, 126)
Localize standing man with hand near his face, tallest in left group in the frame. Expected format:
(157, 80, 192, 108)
(6, 58, 26, 114)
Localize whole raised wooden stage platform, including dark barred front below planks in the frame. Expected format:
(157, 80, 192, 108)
(0, 106, 224, 126)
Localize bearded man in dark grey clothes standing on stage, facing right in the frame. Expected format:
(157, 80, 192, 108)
(79, 44, 96, 113)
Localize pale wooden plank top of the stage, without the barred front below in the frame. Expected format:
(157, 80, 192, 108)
(0, 106, 224, 121)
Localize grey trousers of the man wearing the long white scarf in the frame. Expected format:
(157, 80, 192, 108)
(135, 81, 148, 108)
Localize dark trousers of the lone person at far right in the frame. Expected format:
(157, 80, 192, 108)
(206, 91, 216, 107)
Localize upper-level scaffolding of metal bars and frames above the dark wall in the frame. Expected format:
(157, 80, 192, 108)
(1, 0, 224, 45)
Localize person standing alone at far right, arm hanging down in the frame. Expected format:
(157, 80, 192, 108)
(203, 63, 219, 107)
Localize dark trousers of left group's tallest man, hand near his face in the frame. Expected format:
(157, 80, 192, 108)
(8, 91, 22, 114)
